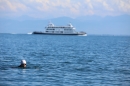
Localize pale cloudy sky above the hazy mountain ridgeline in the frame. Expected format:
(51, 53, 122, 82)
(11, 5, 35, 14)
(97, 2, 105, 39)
(0, 0, 130, 18)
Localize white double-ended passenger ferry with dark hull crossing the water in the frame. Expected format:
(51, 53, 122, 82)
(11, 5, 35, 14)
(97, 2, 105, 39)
(32, 23, 87, 35)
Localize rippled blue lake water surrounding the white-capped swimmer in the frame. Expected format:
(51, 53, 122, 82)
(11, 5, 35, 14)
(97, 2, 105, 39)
(0, 34, 130, 86)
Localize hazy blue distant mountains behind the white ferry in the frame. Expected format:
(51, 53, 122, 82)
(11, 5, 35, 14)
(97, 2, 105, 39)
(0, 15, 130, 35)
